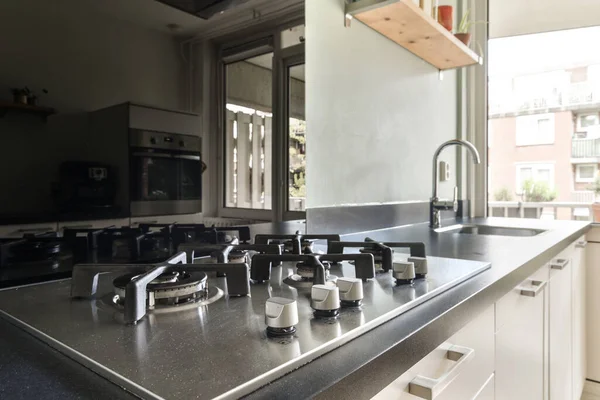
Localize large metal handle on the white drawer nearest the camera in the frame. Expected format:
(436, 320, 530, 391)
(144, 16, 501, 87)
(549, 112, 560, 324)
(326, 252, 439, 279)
(408, 346, 475, 400)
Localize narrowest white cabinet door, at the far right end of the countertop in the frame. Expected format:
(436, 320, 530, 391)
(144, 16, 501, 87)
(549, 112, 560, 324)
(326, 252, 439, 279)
(572, 237, 587, 399)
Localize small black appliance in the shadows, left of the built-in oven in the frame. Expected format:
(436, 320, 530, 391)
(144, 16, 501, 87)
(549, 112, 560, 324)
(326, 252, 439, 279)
(55, 161, 117, 214)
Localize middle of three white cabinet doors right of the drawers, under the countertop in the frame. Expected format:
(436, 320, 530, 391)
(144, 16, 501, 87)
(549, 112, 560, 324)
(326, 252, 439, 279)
(548, 254, 573, 400)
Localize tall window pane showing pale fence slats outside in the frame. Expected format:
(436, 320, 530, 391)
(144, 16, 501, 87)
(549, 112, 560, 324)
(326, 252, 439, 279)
(225, 53, 273, 210)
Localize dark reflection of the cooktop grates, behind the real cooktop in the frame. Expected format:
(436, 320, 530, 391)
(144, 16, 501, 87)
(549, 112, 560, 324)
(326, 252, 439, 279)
(0, 224, 251, 288)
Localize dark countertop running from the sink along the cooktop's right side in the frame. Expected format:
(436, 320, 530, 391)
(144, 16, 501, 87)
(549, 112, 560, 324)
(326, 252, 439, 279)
(250, 218, 591, 399)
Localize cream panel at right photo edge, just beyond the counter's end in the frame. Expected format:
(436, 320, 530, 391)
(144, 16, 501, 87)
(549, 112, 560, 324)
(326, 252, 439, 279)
(586, 241, 600, 381)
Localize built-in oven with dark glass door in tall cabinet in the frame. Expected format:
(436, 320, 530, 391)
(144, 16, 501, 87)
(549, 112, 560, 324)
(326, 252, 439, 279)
(129, 129, 202, 217)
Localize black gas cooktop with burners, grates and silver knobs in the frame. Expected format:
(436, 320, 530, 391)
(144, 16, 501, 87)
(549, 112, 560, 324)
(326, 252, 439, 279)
(0, 244, 490, 399)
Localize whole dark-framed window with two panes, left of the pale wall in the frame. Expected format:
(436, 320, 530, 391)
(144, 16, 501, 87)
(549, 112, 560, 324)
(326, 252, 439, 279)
(217, 24, 307, 220)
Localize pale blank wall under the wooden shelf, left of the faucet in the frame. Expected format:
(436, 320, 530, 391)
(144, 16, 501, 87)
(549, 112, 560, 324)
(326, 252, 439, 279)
(306, 0, 457, 208)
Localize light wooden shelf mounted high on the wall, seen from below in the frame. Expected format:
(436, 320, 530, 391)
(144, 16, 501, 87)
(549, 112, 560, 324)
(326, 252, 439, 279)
(346, 0, 479, 70)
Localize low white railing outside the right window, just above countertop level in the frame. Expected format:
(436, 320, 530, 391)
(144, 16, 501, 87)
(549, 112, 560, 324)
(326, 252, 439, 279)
(488, 201, 594, 221)
